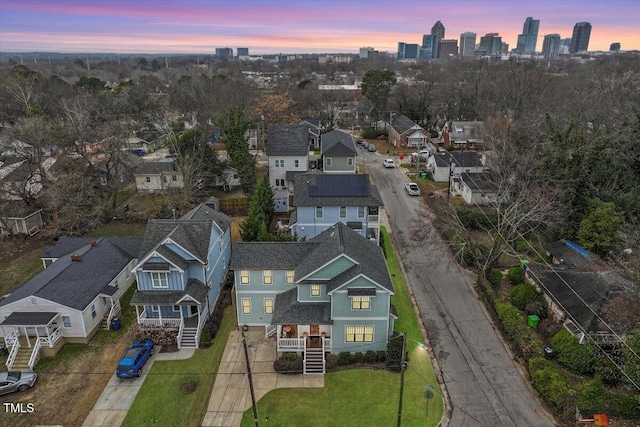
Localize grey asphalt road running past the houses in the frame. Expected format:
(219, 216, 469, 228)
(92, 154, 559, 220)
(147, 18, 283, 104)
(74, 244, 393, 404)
(358, 149, 554, 427)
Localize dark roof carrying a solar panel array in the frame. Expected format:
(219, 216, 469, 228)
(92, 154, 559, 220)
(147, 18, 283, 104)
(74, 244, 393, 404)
(292, 173, 383, 206)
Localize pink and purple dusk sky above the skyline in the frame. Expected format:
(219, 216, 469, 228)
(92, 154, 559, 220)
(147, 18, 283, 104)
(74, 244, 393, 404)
(0, 0, 640, 55)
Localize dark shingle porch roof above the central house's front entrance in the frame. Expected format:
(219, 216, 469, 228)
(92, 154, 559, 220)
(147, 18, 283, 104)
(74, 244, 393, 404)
(271, 287, 333, 325)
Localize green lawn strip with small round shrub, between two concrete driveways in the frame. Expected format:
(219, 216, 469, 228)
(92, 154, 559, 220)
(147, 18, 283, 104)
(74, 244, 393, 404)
(122, 307, 236, 427)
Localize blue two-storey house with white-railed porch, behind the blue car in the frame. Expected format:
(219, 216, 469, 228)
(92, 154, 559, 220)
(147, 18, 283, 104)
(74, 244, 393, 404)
(131, 204, 232, 348)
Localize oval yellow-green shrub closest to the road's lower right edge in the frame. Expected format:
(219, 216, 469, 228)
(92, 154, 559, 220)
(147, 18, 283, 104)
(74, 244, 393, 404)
(529, 357, 569, 411)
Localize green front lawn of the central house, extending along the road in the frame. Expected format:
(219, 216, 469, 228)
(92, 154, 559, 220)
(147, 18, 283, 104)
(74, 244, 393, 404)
(242, 227, 443, 427)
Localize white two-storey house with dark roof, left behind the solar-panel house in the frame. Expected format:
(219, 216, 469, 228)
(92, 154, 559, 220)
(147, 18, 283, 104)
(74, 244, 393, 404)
(266, 125, 309, 212)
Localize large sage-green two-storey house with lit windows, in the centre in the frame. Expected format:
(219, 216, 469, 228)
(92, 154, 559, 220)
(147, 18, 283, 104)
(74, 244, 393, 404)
(231, 223, 397, 373)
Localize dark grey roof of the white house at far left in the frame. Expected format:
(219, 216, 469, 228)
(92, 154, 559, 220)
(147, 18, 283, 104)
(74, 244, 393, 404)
(0, 239, 141, 310)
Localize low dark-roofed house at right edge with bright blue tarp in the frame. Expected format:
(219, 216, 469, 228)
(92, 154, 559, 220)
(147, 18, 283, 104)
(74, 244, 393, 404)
(526, 240, 640, 345)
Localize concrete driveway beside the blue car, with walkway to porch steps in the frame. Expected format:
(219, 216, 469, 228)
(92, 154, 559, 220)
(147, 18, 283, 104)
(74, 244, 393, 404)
(82, 347, 195, 427)
